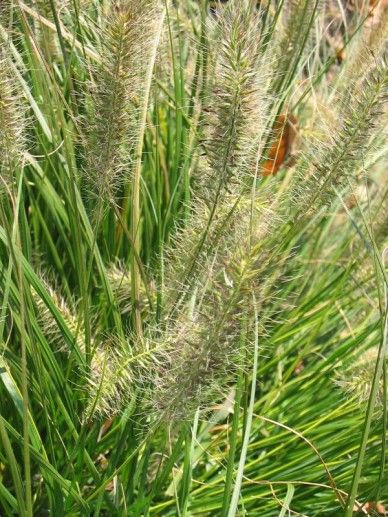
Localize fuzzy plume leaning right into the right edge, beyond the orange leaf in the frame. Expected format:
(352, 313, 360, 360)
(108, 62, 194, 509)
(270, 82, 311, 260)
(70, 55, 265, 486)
(291, 53, 388, 219)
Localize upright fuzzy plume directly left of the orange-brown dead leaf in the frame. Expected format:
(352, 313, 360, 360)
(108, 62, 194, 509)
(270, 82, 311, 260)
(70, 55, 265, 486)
(199, 2, 270, 204)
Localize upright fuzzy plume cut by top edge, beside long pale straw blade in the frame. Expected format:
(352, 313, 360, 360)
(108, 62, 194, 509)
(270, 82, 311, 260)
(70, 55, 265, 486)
(85, 0, 162, 210)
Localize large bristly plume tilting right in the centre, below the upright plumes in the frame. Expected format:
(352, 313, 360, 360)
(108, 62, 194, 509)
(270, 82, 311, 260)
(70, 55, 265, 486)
(147, 192, 279, 420)
